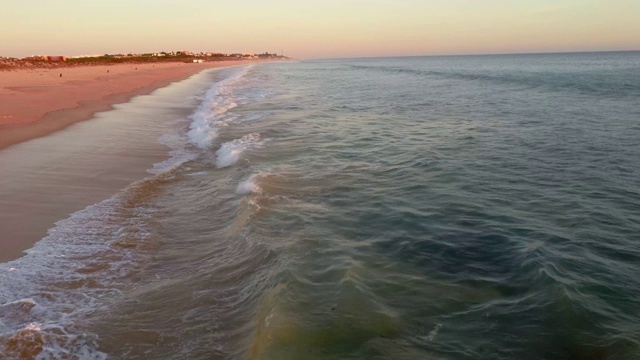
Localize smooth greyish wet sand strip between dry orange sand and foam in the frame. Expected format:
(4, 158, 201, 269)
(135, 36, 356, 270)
(0, 70, 218, 261)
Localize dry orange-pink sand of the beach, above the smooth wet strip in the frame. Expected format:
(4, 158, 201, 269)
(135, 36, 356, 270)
(0, 61, 258, 149)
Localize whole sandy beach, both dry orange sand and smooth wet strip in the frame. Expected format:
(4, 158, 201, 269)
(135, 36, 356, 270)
(0, 61, 258, 261)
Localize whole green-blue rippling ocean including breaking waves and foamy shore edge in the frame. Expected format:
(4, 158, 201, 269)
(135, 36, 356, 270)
(0, 52, 640, 360)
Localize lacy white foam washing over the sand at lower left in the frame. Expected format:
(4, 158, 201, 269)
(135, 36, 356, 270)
(0, 194, 149, 359)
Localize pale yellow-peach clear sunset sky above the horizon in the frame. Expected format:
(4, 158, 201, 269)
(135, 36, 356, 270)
(0, 0, 640, 59)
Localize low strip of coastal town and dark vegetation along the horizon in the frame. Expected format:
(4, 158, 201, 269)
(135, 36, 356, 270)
(0, 50, 289, 70)
